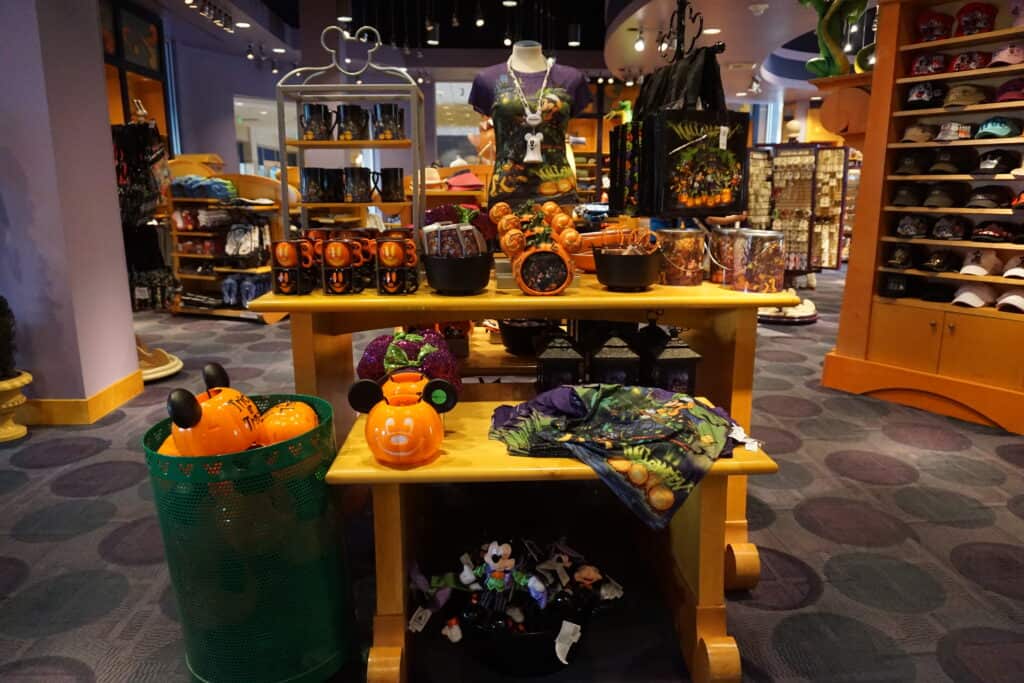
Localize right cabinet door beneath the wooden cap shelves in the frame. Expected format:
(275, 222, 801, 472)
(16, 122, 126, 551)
(939, 312, 1024, 389)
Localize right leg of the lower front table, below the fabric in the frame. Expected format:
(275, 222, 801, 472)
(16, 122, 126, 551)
(665, 476, 741, 683)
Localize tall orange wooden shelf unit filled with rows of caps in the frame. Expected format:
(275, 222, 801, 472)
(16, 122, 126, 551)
(821, 0, 1024, 433)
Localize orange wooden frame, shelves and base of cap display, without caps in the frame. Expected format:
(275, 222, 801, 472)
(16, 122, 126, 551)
(822, 0, 1024, 433)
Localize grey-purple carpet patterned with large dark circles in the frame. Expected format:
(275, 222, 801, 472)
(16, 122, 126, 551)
(0, 270, 1024, 683)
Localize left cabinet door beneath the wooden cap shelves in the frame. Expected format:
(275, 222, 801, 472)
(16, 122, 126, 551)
(867, 300, 943, 373)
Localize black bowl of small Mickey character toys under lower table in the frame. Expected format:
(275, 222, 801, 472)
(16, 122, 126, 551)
(409, 540, 625, 674)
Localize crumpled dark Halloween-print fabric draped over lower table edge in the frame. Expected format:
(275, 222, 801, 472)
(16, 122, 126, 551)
(489, 384, 735, 528)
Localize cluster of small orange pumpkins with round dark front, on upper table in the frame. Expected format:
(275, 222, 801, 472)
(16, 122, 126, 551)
(488, 197, 583, 296)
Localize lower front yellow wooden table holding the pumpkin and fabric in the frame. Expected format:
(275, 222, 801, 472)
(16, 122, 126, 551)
(327, 402, 778, 683)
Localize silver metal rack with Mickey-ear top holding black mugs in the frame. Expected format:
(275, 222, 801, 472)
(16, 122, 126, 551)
(276, 26, 426, 239)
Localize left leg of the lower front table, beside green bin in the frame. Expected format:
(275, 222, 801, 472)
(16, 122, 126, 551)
(367, 484, 409, 683)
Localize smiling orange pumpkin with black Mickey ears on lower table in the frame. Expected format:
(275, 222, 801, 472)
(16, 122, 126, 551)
(348, 373, 457, 467)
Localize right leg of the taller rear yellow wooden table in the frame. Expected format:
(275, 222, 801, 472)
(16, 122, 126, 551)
(666, 308, 761, 590)
